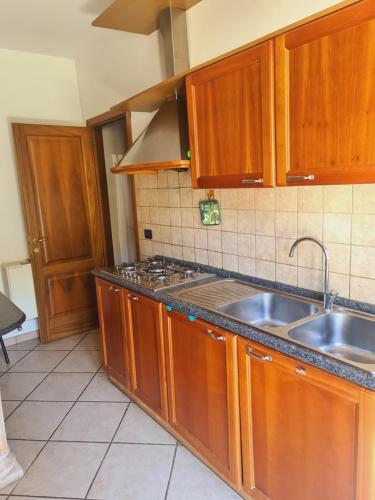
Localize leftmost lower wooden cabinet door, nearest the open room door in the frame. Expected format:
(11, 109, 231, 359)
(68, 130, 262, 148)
(96, 279, 129, 388)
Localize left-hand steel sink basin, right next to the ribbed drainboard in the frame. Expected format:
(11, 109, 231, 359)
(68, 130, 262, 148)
(217, 293, 319, 327)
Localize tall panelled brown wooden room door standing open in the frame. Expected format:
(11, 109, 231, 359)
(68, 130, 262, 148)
(13, 124, 104, 342)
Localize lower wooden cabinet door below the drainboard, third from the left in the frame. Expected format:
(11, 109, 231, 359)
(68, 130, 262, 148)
(166, 312, 240, 486)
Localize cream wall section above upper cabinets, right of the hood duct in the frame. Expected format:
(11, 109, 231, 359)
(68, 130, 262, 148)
(187, 0, 339, 66)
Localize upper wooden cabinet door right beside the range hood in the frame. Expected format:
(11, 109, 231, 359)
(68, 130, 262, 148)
(186, 40, 274, 188)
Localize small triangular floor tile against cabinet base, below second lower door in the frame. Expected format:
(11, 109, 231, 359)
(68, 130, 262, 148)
(114, 404, 176, 445)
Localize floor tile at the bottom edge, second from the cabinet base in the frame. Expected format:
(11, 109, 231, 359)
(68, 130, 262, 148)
(88, 444, 175, 500)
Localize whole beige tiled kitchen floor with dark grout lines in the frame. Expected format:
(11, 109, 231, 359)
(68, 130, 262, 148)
(0, 333, 240, 500)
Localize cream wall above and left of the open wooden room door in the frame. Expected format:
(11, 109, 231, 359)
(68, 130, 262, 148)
(0, 49, 82, 336)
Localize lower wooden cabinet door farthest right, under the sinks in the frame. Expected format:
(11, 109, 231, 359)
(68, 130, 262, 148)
(238, 340, 375, 500)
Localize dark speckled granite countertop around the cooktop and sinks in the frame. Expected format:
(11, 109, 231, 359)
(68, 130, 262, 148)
(93, 259, 375, 390)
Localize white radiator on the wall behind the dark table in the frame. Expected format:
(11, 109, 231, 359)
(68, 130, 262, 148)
(1, 261, 38, 320)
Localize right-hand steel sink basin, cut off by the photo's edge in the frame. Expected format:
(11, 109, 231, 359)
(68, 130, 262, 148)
(288, 312, 375, 364)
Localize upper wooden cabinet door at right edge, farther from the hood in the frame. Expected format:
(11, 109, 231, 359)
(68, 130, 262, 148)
(275, 0, 375, 185)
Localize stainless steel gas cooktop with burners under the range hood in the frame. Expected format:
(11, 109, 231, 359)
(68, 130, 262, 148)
(102, 259, 215, 291)
